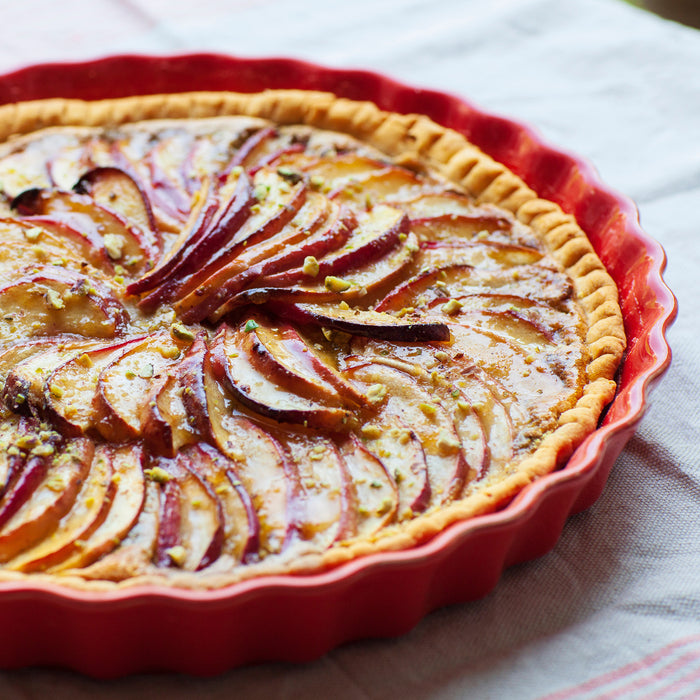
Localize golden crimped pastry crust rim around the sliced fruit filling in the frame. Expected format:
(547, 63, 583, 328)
(0, 90, 625, 590)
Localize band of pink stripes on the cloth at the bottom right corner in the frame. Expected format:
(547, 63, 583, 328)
(540, 635, 700, 700)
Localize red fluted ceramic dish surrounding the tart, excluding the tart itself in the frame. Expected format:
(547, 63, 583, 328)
(0, 54, 677, 677)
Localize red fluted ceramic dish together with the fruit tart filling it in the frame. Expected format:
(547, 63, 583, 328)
(0, 56, 675, 676)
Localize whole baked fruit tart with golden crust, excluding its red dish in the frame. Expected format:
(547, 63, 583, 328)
(0, 90, 625, 589)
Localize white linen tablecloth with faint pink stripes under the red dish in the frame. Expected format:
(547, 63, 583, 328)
(0, 0, 700, 700)
